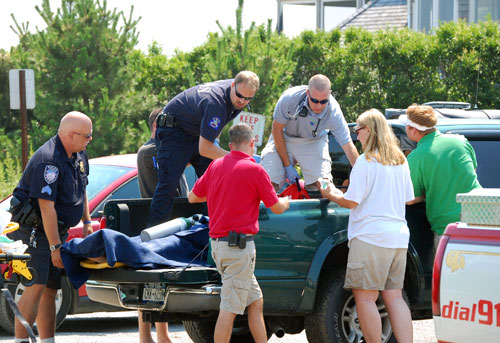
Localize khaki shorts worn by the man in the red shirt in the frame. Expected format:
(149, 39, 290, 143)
(211, 240, 262, 314)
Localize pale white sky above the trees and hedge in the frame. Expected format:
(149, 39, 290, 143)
(0, 0, 354, 56)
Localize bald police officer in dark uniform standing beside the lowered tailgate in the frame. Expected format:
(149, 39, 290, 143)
(9, 112, 92, 343)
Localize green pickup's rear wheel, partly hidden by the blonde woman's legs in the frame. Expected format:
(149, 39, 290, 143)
(305, 269, 396, 343)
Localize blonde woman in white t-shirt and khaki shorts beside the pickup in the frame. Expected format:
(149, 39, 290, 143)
(321, 109, 414, 343)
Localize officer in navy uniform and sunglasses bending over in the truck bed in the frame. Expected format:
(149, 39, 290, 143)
(148, 71, 259, 226)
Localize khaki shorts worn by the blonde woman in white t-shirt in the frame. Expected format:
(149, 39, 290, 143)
(344, 238, 408, 291)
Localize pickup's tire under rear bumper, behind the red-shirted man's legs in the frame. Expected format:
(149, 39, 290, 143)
(182, 317, 273, 343)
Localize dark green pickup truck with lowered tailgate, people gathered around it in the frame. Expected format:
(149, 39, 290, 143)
(87, 119, 500, 343)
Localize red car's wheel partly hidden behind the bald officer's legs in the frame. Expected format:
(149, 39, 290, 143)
(0, 276, 73, 334)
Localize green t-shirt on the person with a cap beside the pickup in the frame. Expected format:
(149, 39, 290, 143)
(408, 130, 481, 235)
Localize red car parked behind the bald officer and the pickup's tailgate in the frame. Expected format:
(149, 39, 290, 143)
(0, 154, 195, 333)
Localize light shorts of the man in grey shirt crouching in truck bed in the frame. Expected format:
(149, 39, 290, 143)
(260, 137, 332, 187)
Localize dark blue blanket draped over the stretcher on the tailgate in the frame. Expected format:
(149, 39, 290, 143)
(61, 217, 208, 288)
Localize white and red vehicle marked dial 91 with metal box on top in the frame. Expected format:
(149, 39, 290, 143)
(432, 189, 500, 343)
